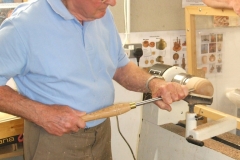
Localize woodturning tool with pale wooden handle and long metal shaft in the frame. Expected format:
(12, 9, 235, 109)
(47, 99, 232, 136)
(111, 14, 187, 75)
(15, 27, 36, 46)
(81, 89, 194, 122)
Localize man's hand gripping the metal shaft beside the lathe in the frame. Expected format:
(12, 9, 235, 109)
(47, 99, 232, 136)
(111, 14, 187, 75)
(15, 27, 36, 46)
(149, 78, 188, 111)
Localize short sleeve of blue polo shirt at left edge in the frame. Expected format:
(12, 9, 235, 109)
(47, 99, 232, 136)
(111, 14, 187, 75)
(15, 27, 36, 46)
(0, 19, 26, 85)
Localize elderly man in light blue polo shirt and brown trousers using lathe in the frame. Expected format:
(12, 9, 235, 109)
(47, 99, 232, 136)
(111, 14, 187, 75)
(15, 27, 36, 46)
(0, 0, 188, 160)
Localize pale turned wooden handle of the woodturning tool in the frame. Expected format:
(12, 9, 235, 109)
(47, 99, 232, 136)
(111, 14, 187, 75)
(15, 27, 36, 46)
(81, 103, 131, 122)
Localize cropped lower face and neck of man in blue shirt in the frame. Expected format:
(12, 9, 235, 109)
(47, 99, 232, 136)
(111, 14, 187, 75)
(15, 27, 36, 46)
(62, 0, 116, 22)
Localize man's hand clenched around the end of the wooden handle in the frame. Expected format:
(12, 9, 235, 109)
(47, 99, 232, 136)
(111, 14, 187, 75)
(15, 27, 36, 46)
(36, 105, 86, 136)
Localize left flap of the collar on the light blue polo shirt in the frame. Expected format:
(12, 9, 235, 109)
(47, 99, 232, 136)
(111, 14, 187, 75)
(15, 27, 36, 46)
(47, 0, 74, 20)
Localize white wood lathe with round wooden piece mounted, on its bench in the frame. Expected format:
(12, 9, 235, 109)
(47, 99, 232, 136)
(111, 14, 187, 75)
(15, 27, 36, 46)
(137, 64, 240, 160)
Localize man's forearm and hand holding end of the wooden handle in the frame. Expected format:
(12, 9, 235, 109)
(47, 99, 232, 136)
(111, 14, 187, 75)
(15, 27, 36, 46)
(0, 86, 85, 136)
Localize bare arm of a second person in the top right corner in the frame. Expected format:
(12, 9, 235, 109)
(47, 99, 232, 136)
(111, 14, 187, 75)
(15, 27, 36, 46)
(202, 0, 240, 15)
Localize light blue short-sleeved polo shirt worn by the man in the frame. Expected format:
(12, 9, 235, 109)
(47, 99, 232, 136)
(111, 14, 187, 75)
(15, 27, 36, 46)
(0, 0, 129, 127)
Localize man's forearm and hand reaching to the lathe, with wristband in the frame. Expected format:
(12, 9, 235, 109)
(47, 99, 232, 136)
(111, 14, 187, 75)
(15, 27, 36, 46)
(113, 62, 188, 111)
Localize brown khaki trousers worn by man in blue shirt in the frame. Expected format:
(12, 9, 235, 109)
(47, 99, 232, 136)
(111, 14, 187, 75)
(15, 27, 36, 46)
(23, 118, 112, 160)
